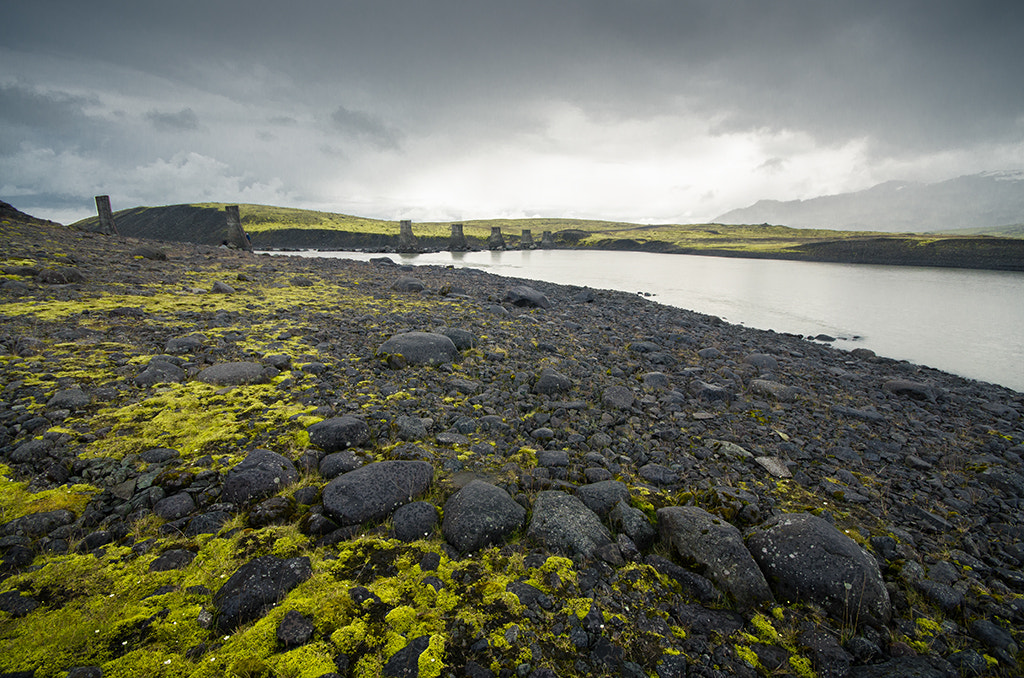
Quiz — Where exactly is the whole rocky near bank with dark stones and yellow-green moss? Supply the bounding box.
[0,214,1024,678]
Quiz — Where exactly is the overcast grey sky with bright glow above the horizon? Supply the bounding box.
[0,0,1024,222]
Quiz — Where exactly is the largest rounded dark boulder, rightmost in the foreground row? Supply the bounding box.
[746,513,891,627]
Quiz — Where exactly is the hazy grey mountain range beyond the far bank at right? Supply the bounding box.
[715,171,1024,233]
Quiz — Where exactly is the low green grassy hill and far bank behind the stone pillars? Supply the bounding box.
[73,203,1024,270]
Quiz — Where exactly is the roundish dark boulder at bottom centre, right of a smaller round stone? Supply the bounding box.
[441,480,526,553]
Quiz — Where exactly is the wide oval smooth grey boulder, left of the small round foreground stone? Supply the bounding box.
[323,461,434,526]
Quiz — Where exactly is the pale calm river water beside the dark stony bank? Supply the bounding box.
[270,250,1024,391]
